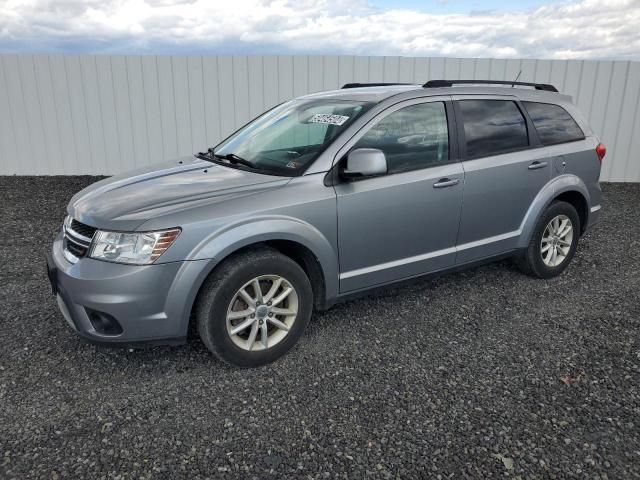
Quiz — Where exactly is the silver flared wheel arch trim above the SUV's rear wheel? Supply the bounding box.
[518,174,591,248]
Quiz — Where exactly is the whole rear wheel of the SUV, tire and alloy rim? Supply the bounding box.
[518,201,580,278]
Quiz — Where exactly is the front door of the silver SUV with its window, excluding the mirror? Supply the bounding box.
[334,97,464,293]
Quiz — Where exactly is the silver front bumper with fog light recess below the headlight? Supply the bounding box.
[47,235,212,344]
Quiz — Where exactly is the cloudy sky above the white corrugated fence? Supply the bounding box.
[0,0,640,60]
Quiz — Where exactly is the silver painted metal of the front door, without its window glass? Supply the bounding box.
[335,95,464,293]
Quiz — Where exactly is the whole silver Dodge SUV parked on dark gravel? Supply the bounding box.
[47,80,605,366]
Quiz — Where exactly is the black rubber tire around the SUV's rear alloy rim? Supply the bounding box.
[516,201,580,278]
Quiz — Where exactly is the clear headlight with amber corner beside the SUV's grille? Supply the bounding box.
[89,228,180,265]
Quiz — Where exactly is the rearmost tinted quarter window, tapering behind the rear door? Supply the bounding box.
[523,102,584,145]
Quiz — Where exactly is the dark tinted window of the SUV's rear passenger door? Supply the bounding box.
[459,100,529,158]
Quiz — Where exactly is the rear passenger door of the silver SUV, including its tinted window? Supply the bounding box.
[454,95,552,263]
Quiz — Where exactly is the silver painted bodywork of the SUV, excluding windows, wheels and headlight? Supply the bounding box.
[48,86,600,342]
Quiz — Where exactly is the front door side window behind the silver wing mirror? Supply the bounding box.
[354,102,449,173]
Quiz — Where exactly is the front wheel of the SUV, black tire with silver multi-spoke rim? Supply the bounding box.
[195,247,313,367]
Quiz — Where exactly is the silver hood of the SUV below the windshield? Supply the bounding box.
[67,157,291,231]
